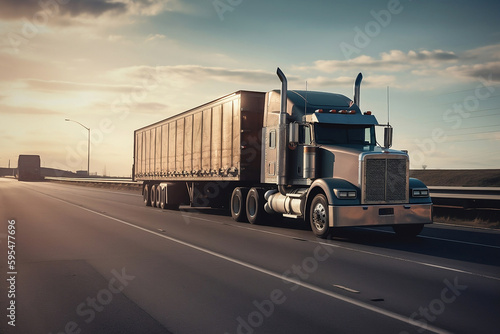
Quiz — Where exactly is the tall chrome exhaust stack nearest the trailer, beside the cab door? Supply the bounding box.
[276,67,288,195]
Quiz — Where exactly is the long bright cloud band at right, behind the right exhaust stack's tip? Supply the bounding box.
[293,44,500,89]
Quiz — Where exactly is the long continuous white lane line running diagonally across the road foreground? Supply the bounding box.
[37,194,450,334]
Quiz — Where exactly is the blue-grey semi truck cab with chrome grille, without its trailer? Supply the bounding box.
[261,70,432,237]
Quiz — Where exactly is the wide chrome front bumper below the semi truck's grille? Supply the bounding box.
[328,204,432,227]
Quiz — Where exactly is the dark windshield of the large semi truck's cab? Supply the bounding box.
[314,123,376,145]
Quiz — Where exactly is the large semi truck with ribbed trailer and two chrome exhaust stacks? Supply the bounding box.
[133,68,432,238]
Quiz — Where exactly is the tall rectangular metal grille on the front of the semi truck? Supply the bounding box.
[363,157,408,204]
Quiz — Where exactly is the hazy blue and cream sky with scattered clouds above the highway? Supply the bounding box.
[0,0,500,176]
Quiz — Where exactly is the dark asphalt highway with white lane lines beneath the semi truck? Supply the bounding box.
[0,179,500,334]
